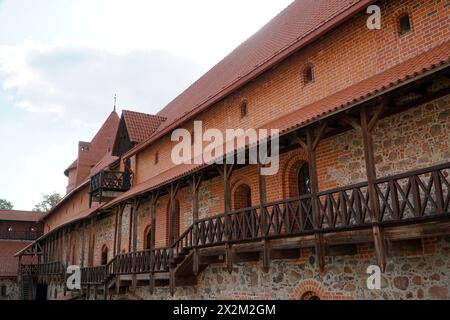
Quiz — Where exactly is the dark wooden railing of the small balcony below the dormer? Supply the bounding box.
[91,170,131,194]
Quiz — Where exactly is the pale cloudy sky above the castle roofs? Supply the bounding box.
[0,0,293,210]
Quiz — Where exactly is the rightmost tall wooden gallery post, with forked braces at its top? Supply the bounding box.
[360,103,386,272]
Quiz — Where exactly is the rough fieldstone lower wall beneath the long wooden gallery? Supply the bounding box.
[118,237,450,300]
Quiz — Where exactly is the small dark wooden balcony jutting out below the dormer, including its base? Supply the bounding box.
[90,170,131,204]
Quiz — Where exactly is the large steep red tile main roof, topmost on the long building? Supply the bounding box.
[125,0,375,157]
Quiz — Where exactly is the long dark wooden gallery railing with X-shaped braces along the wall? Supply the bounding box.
[75,163,450,286]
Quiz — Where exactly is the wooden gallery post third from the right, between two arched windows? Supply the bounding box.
[258,159,270,273]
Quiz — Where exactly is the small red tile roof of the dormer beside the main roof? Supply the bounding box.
[122,110,166,143]
